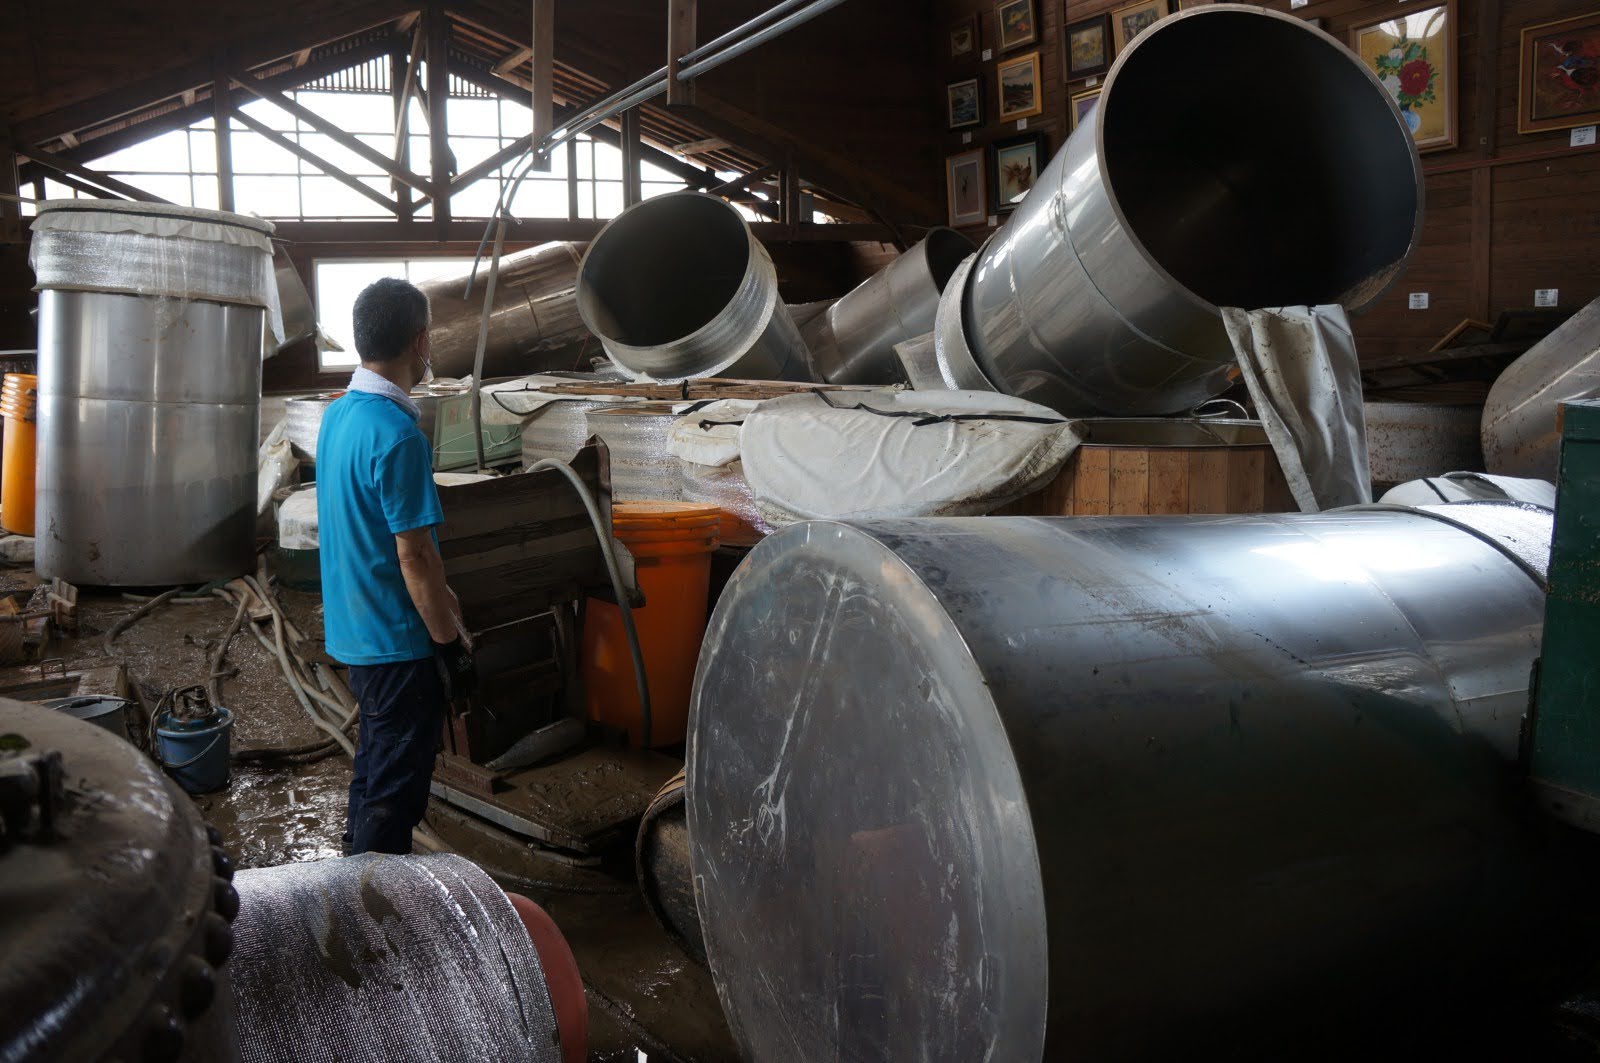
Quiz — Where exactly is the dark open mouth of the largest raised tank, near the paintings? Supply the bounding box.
[1099,11,1419,309]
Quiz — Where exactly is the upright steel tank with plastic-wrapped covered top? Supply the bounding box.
[29,200,274,586]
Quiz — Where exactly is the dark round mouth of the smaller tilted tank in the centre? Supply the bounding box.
[578,192,750,347]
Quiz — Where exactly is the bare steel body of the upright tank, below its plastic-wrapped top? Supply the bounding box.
[35,288,266,586]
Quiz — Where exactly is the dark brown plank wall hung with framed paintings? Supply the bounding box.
[934,0,1600,359]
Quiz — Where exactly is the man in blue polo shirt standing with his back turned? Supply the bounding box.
[317,277,474,853]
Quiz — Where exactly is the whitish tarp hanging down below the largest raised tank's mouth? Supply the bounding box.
[1222,306,1373,512]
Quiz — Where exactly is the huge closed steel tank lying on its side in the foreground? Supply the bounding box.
[688,503,1592,1061]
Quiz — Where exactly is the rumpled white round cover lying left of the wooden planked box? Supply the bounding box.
[732,391,1080,527]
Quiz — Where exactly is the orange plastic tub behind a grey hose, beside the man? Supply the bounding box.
[582,501,722,746]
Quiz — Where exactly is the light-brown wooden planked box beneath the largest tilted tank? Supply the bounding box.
[997,418,1299,517]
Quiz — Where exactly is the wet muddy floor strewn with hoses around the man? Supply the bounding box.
[15,568,738,1063]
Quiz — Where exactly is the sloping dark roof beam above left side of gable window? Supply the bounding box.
[13,0,410,144]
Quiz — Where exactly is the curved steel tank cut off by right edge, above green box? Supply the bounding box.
[1480,299,1600,483]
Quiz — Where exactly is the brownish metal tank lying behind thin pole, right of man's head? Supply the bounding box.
[418,243,598,378]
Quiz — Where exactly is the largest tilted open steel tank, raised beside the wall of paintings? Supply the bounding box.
[938,3,1422,416]
